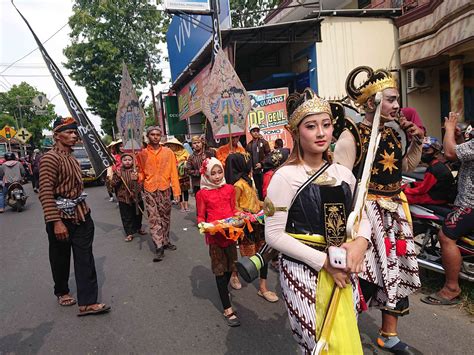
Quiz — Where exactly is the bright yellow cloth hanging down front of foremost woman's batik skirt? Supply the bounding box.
[316,269,363,354]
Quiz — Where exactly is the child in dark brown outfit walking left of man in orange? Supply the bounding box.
[111,153,146,242]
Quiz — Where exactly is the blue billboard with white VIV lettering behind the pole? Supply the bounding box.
[166,0,231,82]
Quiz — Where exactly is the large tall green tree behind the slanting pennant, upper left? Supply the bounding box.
[64,0,169,134]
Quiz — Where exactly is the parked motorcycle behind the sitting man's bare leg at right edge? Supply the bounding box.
[403,172,474,281]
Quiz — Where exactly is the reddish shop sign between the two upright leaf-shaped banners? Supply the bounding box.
[178,64,211,120]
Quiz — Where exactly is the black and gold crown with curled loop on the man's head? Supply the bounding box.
[346,66,398,106]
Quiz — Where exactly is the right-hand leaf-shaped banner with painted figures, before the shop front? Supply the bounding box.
[202,49,250,139]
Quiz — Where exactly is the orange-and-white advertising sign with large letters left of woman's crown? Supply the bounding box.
[246,88,293,149]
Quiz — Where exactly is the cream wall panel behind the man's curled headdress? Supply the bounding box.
[316,17,400,98]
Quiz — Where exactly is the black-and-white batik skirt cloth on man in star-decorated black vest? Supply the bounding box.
[359,200,421,309]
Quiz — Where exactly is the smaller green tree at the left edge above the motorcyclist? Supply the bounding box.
[0,82,56,147]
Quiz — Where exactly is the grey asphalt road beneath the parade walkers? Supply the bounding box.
[0,186,474,354]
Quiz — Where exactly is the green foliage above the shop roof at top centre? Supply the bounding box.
[230,0,282,27]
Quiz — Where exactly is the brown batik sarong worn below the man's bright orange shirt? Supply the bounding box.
[143,189,171,248]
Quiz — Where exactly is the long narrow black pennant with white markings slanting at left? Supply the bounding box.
[12,0,114,176]
